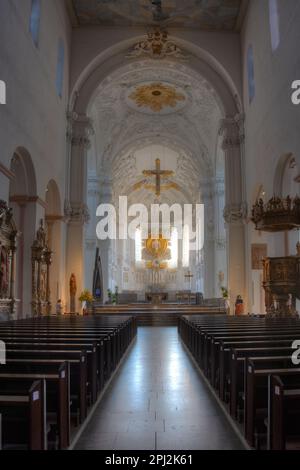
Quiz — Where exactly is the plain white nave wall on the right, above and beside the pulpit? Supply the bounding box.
[241,0,300,313]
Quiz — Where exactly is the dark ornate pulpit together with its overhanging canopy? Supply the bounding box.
[252,196,300,316]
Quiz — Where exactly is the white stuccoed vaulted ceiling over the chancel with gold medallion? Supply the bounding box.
[89,60,222,203]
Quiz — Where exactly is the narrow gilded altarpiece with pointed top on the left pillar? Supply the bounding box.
[31,220,52,316]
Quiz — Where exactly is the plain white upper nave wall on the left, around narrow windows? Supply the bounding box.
[0,0,71,204]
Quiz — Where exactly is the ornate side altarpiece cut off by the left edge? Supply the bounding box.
[0,201,18,320]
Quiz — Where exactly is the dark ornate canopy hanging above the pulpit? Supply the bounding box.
[251,196,300,232]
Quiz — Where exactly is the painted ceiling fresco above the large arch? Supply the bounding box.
[71,0,243,31]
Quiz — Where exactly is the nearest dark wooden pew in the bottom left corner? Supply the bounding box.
[0,378,46,450]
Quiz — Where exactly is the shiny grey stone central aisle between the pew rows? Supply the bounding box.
[76,327,243,450]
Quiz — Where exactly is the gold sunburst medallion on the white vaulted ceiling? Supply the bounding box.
[129,83,185,113]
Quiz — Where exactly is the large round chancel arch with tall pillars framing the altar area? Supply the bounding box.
[67,36,247,314]
